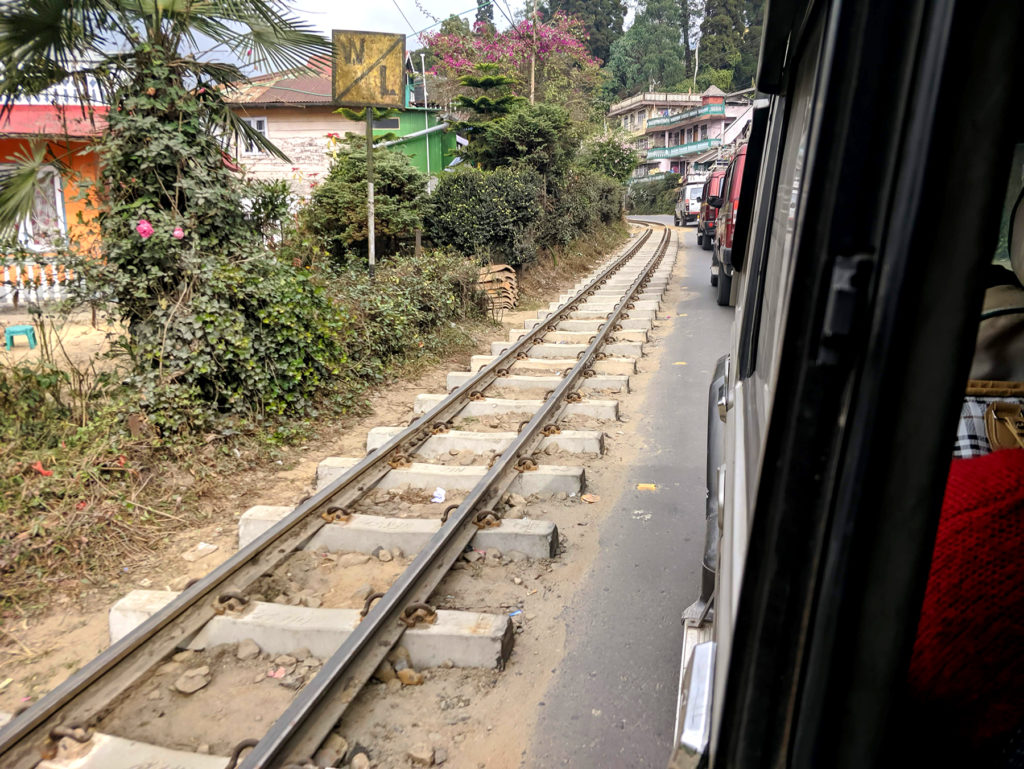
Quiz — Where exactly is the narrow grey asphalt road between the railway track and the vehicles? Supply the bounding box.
[522,216,733,769]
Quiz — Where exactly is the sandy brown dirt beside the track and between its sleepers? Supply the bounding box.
[0,222,680,769]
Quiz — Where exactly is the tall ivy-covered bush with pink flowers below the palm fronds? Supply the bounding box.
[62,46,343,431]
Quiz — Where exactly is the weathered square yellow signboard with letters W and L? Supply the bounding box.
[332,30,406,108]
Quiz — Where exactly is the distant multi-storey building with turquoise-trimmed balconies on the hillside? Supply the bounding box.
[608,86,751,179]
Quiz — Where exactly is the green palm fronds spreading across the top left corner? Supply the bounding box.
[0,0,331,232]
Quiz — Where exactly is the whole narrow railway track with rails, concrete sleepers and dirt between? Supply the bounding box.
[0,219,675,769]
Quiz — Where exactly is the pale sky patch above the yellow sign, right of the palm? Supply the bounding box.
[290,0,522,48]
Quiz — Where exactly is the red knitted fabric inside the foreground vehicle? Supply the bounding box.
[909,450,1024,744]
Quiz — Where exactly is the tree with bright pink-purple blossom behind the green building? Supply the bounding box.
[423,13,603,120]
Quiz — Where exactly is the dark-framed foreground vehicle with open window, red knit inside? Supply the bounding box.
[670,0,1024,769]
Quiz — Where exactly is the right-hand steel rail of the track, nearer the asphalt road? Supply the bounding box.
[241,227,672,769]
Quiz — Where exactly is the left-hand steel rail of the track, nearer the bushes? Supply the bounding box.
[0,224,652,769]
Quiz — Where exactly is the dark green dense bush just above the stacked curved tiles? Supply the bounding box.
[425,166,544,265]
